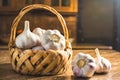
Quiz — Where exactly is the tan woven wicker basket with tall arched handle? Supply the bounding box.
[9,4,72,75]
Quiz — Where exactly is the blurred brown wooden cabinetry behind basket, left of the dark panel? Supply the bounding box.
[0,0,78,44]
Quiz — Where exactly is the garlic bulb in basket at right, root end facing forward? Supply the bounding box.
[41,30,65,50]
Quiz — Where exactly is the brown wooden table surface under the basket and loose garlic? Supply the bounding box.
[0,50,120,80]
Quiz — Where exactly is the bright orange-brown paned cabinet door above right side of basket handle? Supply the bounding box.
[44,0,78,12]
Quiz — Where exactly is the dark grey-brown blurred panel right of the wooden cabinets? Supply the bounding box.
[77,0,115,45]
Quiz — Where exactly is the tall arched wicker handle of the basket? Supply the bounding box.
[8,4,70,48]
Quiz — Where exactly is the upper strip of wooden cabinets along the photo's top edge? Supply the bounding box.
[0,0,78,12]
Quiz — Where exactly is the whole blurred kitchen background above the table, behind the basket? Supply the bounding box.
[0,0,120,50]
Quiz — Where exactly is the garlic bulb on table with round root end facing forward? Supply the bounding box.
[72,53,96,77]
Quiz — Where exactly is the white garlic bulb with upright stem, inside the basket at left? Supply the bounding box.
[15,21,40,49]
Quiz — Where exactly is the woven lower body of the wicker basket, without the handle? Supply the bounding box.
[10,48,72,75]
